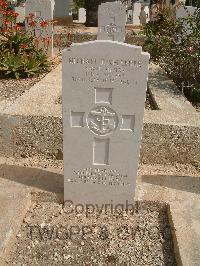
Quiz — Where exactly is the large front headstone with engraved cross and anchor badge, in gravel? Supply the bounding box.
[62,41,149,204]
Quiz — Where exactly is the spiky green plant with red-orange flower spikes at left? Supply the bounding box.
[0,0,56,78]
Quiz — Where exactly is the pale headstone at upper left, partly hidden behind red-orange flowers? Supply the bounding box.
[25,0,54,56]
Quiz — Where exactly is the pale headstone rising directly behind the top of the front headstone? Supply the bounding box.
[97,2,126,42]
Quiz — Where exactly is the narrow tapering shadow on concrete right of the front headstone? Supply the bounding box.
[141,175,200,194]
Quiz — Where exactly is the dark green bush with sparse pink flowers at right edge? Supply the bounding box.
[144,6,200,102]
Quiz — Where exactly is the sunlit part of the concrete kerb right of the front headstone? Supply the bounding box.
[138,176,200,266]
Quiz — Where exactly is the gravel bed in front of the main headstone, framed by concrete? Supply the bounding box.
[6,202,176,266]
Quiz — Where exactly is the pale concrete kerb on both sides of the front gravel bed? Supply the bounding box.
[0,160,200,266]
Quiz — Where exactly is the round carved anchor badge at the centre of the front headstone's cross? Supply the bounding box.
[87,106,119,136]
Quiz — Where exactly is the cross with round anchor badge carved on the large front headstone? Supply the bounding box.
[70,88,135,165]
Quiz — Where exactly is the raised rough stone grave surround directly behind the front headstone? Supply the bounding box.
[0,65,200,164]
